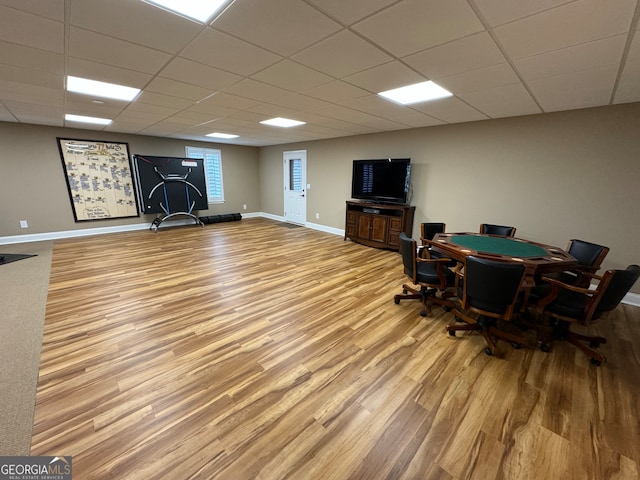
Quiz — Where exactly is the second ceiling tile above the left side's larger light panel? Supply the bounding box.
[69,27,171,73]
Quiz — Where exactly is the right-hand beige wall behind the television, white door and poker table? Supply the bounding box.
[260,103,640,293]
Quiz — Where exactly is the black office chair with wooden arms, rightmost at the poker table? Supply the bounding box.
[532,265,640,365]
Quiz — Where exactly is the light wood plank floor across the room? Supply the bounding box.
[32,219,640,480]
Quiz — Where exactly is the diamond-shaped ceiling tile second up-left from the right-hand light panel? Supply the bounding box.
[291,30,393,78]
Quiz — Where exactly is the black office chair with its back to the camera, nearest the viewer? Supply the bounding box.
[447,256,528,355]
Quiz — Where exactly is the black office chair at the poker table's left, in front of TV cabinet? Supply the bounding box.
[393,232,455,317]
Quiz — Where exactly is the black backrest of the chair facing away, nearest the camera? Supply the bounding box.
[463,256,525,319]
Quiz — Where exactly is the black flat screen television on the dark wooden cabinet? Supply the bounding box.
[351,158,411,204]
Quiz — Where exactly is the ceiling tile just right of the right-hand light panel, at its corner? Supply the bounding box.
[460,84,542,118]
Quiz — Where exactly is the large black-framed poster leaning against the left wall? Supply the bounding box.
[58,137,140,222]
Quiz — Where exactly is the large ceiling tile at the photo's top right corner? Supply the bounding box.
[495,0,637,60]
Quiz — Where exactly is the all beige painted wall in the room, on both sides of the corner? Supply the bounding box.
[0,103,640,293]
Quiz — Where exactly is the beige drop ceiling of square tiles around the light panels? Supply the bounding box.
[0,0,640,146]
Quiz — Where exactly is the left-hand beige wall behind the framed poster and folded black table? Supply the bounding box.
[0,122,260,237]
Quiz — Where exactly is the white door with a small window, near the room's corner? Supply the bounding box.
[284,150,307,225]
